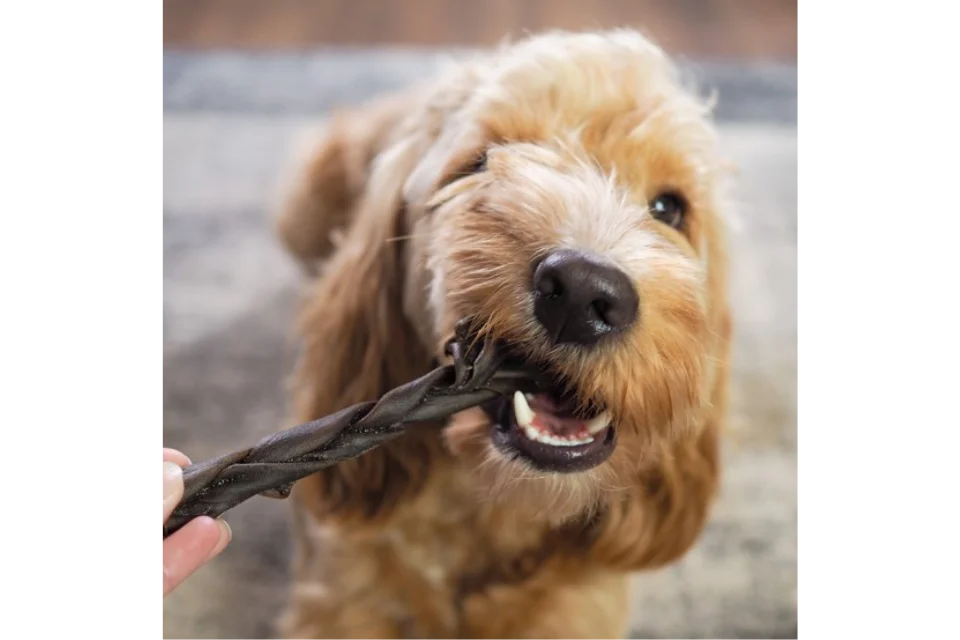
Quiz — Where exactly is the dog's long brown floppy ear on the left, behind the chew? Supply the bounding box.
[280,105,437,518]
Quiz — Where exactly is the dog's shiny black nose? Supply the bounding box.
[533,250,640,346]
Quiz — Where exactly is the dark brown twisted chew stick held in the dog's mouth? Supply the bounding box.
[160,321,536,542]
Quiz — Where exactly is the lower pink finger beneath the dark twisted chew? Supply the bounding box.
[160,516,232,598]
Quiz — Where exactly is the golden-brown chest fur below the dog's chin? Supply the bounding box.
[295,462,608,640]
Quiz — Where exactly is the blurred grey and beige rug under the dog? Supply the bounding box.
[160,51,800,640]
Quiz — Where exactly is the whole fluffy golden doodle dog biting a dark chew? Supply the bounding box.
[278,30,731,640]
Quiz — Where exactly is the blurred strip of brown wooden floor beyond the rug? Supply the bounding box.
[161,0,800,60]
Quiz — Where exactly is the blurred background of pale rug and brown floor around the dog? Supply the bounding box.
[160,0,800,640]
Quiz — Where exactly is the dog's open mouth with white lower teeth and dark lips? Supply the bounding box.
[483,350,616,473]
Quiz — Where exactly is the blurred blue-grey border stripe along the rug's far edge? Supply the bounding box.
[160,49,800,125]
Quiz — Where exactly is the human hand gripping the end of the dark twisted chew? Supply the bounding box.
[160,449,231,599]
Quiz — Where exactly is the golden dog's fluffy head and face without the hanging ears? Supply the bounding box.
[284,31,726,536]
